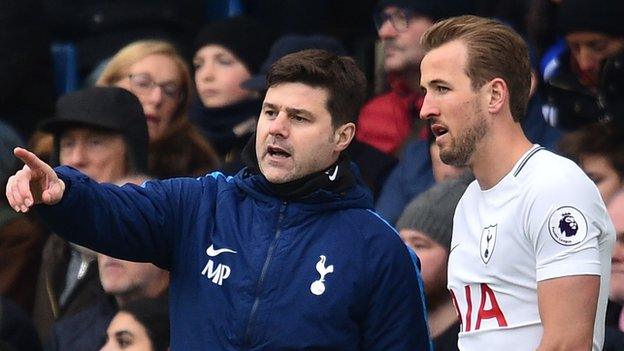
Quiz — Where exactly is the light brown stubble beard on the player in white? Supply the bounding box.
[440,100,488,167]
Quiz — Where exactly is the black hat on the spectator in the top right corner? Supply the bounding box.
[557,0,624,37]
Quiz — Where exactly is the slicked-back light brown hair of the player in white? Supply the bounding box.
[421,16,531,122]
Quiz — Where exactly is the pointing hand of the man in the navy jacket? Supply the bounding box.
[6,147,65,212]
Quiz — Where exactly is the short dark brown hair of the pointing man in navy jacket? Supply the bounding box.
[267,49,366,128]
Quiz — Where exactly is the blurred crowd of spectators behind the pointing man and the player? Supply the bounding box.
[0,0,624,350]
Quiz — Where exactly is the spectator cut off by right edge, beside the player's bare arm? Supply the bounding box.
[604,188,624,351]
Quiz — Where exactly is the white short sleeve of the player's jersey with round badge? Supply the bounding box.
[525,174,606,281]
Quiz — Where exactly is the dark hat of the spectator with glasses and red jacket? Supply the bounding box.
[377,0,474,22]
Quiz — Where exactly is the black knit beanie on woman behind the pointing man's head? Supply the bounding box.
[194,17,271,74]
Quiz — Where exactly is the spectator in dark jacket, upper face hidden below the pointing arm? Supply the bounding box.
[46,248,169,351]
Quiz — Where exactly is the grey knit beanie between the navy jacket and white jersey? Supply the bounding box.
[397,172,474,250]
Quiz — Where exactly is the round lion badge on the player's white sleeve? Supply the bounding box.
[548,206,587,246]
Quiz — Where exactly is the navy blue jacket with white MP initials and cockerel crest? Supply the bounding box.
[38,167,431,350]
